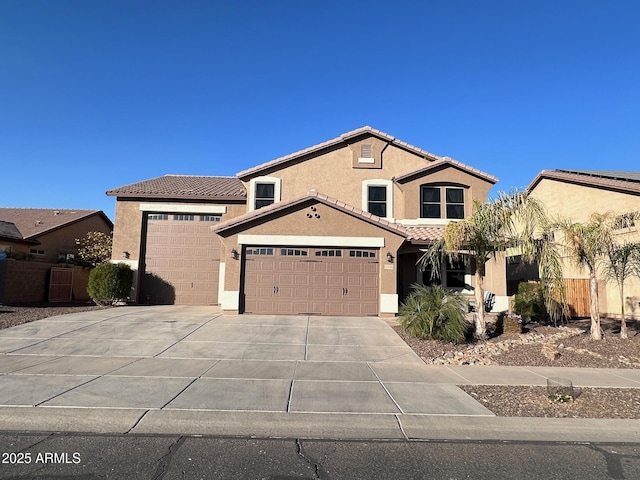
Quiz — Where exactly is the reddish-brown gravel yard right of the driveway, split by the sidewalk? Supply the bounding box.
[394,319,640,419]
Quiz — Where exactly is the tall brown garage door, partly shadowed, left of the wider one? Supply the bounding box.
[139,213,220,305]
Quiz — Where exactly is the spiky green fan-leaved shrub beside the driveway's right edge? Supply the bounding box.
[400,285,470,343]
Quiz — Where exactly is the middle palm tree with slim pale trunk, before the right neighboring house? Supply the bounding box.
[554,212,640,340]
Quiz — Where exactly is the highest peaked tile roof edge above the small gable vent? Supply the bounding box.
[237,125,443,178]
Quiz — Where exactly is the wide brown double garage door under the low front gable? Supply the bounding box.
[244,247,379,316]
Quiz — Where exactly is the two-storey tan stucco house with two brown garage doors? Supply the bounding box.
[107,127,506,316]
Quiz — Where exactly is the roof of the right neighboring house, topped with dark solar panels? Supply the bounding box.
[527,170,640,195]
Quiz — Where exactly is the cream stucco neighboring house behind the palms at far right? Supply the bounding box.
[524,170,640,318]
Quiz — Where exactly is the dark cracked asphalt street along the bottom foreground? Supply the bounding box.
[0,433,640,480]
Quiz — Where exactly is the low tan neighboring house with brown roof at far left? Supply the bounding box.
[0,208,113,263]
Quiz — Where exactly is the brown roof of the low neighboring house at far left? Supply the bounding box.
[0,208,113,239]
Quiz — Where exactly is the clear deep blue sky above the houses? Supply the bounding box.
[0,0,640,219]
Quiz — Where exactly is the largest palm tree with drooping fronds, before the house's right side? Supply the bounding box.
[418,191,562,338]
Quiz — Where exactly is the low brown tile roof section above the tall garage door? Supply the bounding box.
[107,175,247,200]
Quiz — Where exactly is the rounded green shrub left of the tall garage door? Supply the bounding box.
[87,263,133,305]
